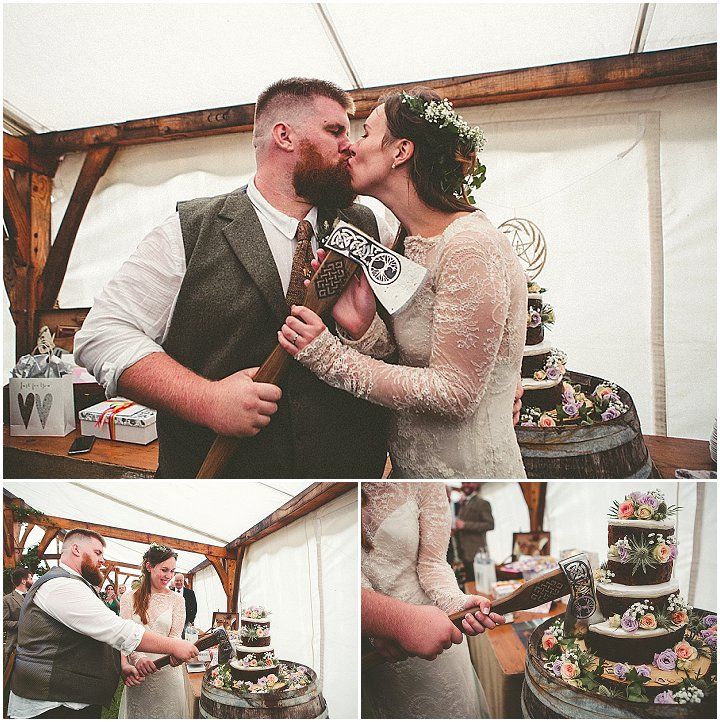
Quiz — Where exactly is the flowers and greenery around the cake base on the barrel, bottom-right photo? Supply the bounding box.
[541,612,717,704]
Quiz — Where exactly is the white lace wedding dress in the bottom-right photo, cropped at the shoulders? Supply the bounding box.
[362,481,489,719]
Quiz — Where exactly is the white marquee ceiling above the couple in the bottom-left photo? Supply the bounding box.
[3,480,310,571]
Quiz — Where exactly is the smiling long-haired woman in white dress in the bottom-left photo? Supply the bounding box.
[118,544,194,719]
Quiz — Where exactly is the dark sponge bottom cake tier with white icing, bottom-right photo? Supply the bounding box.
[585,622,686,664]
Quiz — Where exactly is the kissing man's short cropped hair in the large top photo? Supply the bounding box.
[253,78,355,146]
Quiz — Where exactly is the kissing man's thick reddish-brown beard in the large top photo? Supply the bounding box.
[292,140,355,208]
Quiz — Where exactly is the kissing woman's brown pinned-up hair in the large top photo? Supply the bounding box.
[378,87,484,211]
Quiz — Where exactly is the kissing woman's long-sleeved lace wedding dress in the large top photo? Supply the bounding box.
[296,211,527,479]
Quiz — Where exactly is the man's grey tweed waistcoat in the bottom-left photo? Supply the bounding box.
[10,567,120,707]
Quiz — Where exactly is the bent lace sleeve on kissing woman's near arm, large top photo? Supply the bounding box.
[296,225,510,419]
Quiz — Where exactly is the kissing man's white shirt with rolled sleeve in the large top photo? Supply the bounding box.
[74,177,393,398]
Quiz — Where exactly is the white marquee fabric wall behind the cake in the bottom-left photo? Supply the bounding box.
[194,493,360,718]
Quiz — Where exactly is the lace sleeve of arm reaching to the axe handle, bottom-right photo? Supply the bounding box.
[417,482,468,614]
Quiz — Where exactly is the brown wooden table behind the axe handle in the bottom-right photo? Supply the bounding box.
[465,582,566,719]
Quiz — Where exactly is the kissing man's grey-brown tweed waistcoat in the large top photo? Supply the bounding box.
[158,188,388,478]
